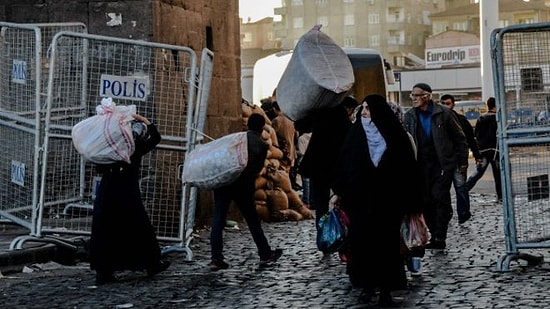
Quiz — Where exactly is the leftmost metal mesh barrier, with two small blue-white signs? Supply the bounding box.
[0,22,87,235]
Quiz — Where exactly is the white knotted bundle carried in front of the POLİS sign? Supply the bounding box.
[71,98,136,164]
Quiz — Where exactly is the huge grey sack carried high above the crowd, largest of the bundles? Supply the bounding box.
[277,26,355,120]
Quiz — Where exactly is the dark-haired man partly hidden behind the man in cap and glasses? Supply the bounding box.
[440,94,481,224]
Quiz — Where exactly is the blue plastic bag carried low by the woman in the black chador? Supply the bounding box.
[317,208,346,253]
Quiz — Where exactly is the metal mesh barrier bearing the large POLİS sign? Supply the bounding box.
[29,31,213,259]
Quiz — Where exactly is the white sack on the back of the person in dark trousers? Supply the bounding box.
[182,132,248,190]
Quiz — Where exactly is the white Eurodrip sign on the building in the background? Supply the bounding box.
[424,45,481,69]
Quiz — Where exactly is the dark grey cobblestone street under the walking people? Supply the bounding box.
[0,194,550,308]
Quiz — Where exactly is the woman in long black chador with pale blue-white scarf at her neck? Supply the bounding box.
[333,95,422,305]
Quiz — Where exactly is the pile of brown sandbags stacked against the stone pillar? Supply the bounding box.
[241,102,313,222]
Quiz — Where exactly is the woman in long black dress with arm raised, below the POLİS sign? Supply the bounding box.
[90,115,169,284]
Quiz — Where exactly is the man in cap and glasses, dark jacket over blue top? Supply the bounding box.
[405,83,468,249]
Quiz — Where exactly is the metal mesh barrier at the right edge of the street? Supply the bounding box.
[491,23,550,271]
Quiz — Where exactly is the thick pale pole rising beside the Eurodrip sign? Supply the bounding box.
[479,0,499,101]
